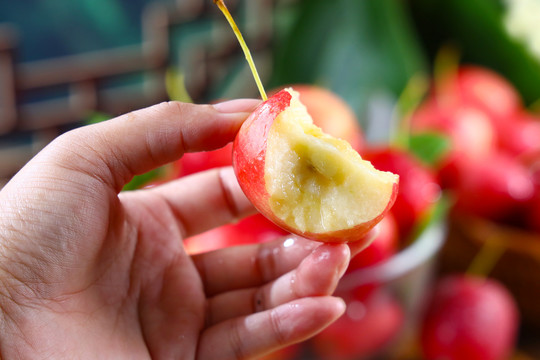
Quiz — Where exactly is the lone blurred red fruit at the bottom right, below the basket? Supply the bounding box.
[421,275,519,360]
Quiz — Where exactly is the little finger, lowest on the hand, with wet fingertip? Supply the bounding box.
[198,296,345,360]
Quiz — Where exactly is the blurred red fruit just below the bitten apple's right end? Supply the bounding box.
[347,212,399,272]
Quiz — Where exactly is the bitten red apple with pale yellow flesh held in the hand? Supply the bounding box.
[233,89,399,242]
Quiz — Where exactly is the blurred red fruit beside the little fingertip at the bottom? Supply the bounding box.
[311,289,405,360]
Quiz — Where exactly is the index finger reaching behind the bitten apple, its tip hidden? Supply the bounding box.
[133,167,255,238]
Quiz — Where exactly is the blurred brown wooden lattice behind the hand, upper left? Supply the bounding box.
[0,0,275,179]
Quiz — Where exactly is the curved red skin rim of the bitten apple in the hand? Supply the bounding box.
[233,90,399,243]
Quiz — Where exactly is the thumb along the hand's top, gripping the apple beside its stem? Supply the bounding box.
[45,99,259,191]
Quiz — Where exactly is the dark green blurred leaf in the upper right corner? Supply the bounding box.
[410,0,540,104]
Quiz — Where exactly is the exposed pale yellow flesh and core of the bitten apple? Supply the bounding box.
[264,89,398,233]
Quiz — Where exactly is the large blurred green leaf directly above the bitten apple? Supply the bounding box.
[273,0,426,119]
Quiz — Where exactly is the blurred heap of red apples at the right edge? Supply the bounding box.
[411,66,540,231]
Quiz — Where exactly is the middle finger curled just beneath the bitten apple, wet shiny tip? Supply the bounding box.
[192,235,321,296]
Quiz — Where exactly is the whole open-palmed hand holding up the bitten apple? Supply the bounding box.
[0,100,362,360]
